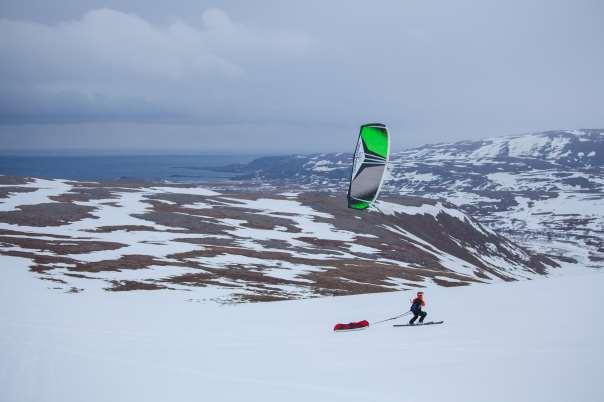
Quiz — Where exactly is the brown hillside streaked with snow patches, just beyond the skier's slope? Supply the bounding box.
[0,177,559,302]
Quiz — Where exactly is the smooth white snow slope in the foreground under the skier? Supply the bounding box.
[0,257,604,402]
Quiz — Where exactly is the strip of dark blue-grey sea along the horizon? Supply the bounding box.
[0,154,260,182]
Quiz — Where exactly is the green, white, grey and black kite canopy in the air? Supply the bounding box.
[348,123,390,209]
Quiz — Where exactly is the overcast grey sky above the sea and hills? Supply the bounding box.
[0,0,604,153]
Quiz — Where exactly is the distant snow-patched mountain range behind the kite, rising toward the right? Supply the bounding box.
[214,129,604,267]
